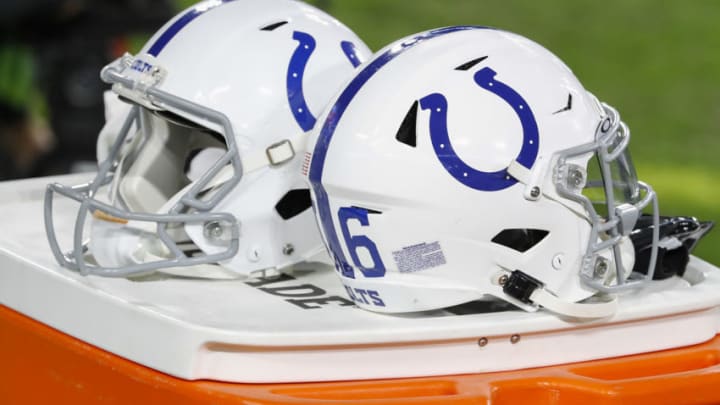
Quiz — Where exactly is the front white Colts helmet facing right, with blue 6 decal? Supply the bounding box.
[307,27,658,318]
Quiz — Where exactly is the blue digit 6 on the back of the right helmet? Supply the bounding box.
[338,207,385,277]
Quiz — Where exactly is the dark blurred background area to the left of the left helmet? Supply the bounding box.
[0,0,177,179]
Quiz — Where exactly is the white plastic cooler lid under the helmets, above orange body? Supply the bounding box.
[0,176,720,382]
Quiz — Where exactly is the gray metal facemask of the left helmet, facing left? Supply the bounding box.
[44,55,248,277]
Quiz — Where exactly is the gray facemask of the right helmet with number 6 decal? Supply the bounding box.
[555,103,660,293]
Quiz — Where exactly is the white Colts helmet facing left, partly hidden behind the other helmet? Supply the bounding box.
[45,0,370,277]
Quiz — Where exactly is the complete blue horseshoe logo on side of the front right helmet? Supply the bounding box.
[420,67,539,191]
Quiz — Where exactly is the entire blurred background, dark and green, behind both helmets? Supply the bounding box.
[0,0,720,264]
